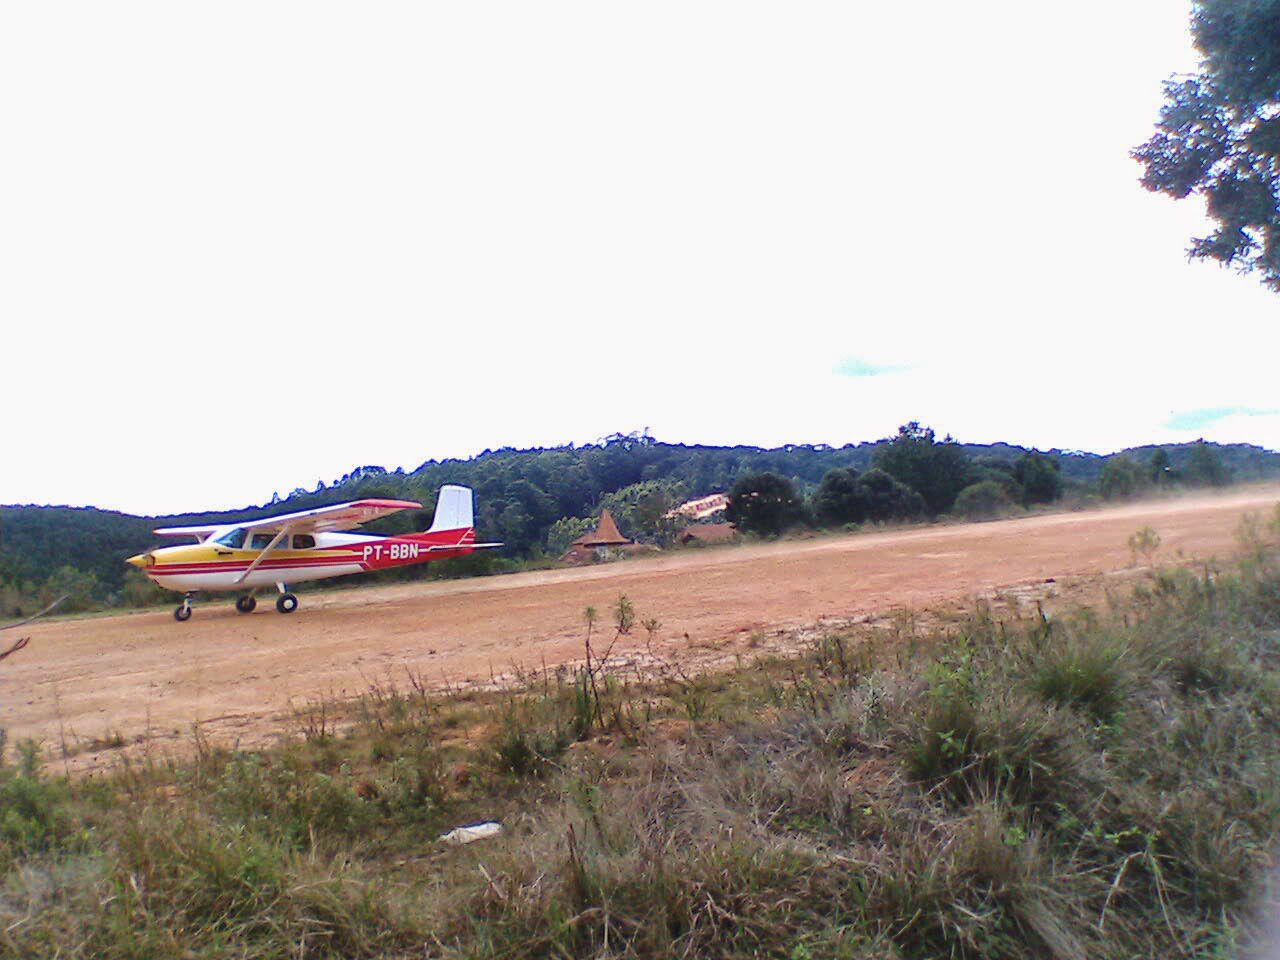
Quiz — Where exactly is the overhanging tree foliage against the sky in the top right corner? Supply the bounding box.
[1133,0,1280,292]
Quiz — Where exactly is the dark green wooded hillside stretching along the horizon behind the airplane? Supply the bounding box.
[0,435,1280,616]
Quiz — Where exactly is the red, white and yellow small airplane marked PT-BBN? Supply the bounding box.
[125,484,502,623]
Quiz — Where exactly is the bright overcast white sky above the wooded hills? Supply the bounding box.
[0,0,1280,513]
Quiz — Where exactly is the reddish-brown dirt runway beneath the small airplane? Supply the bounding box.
[0,485,1280,768]
